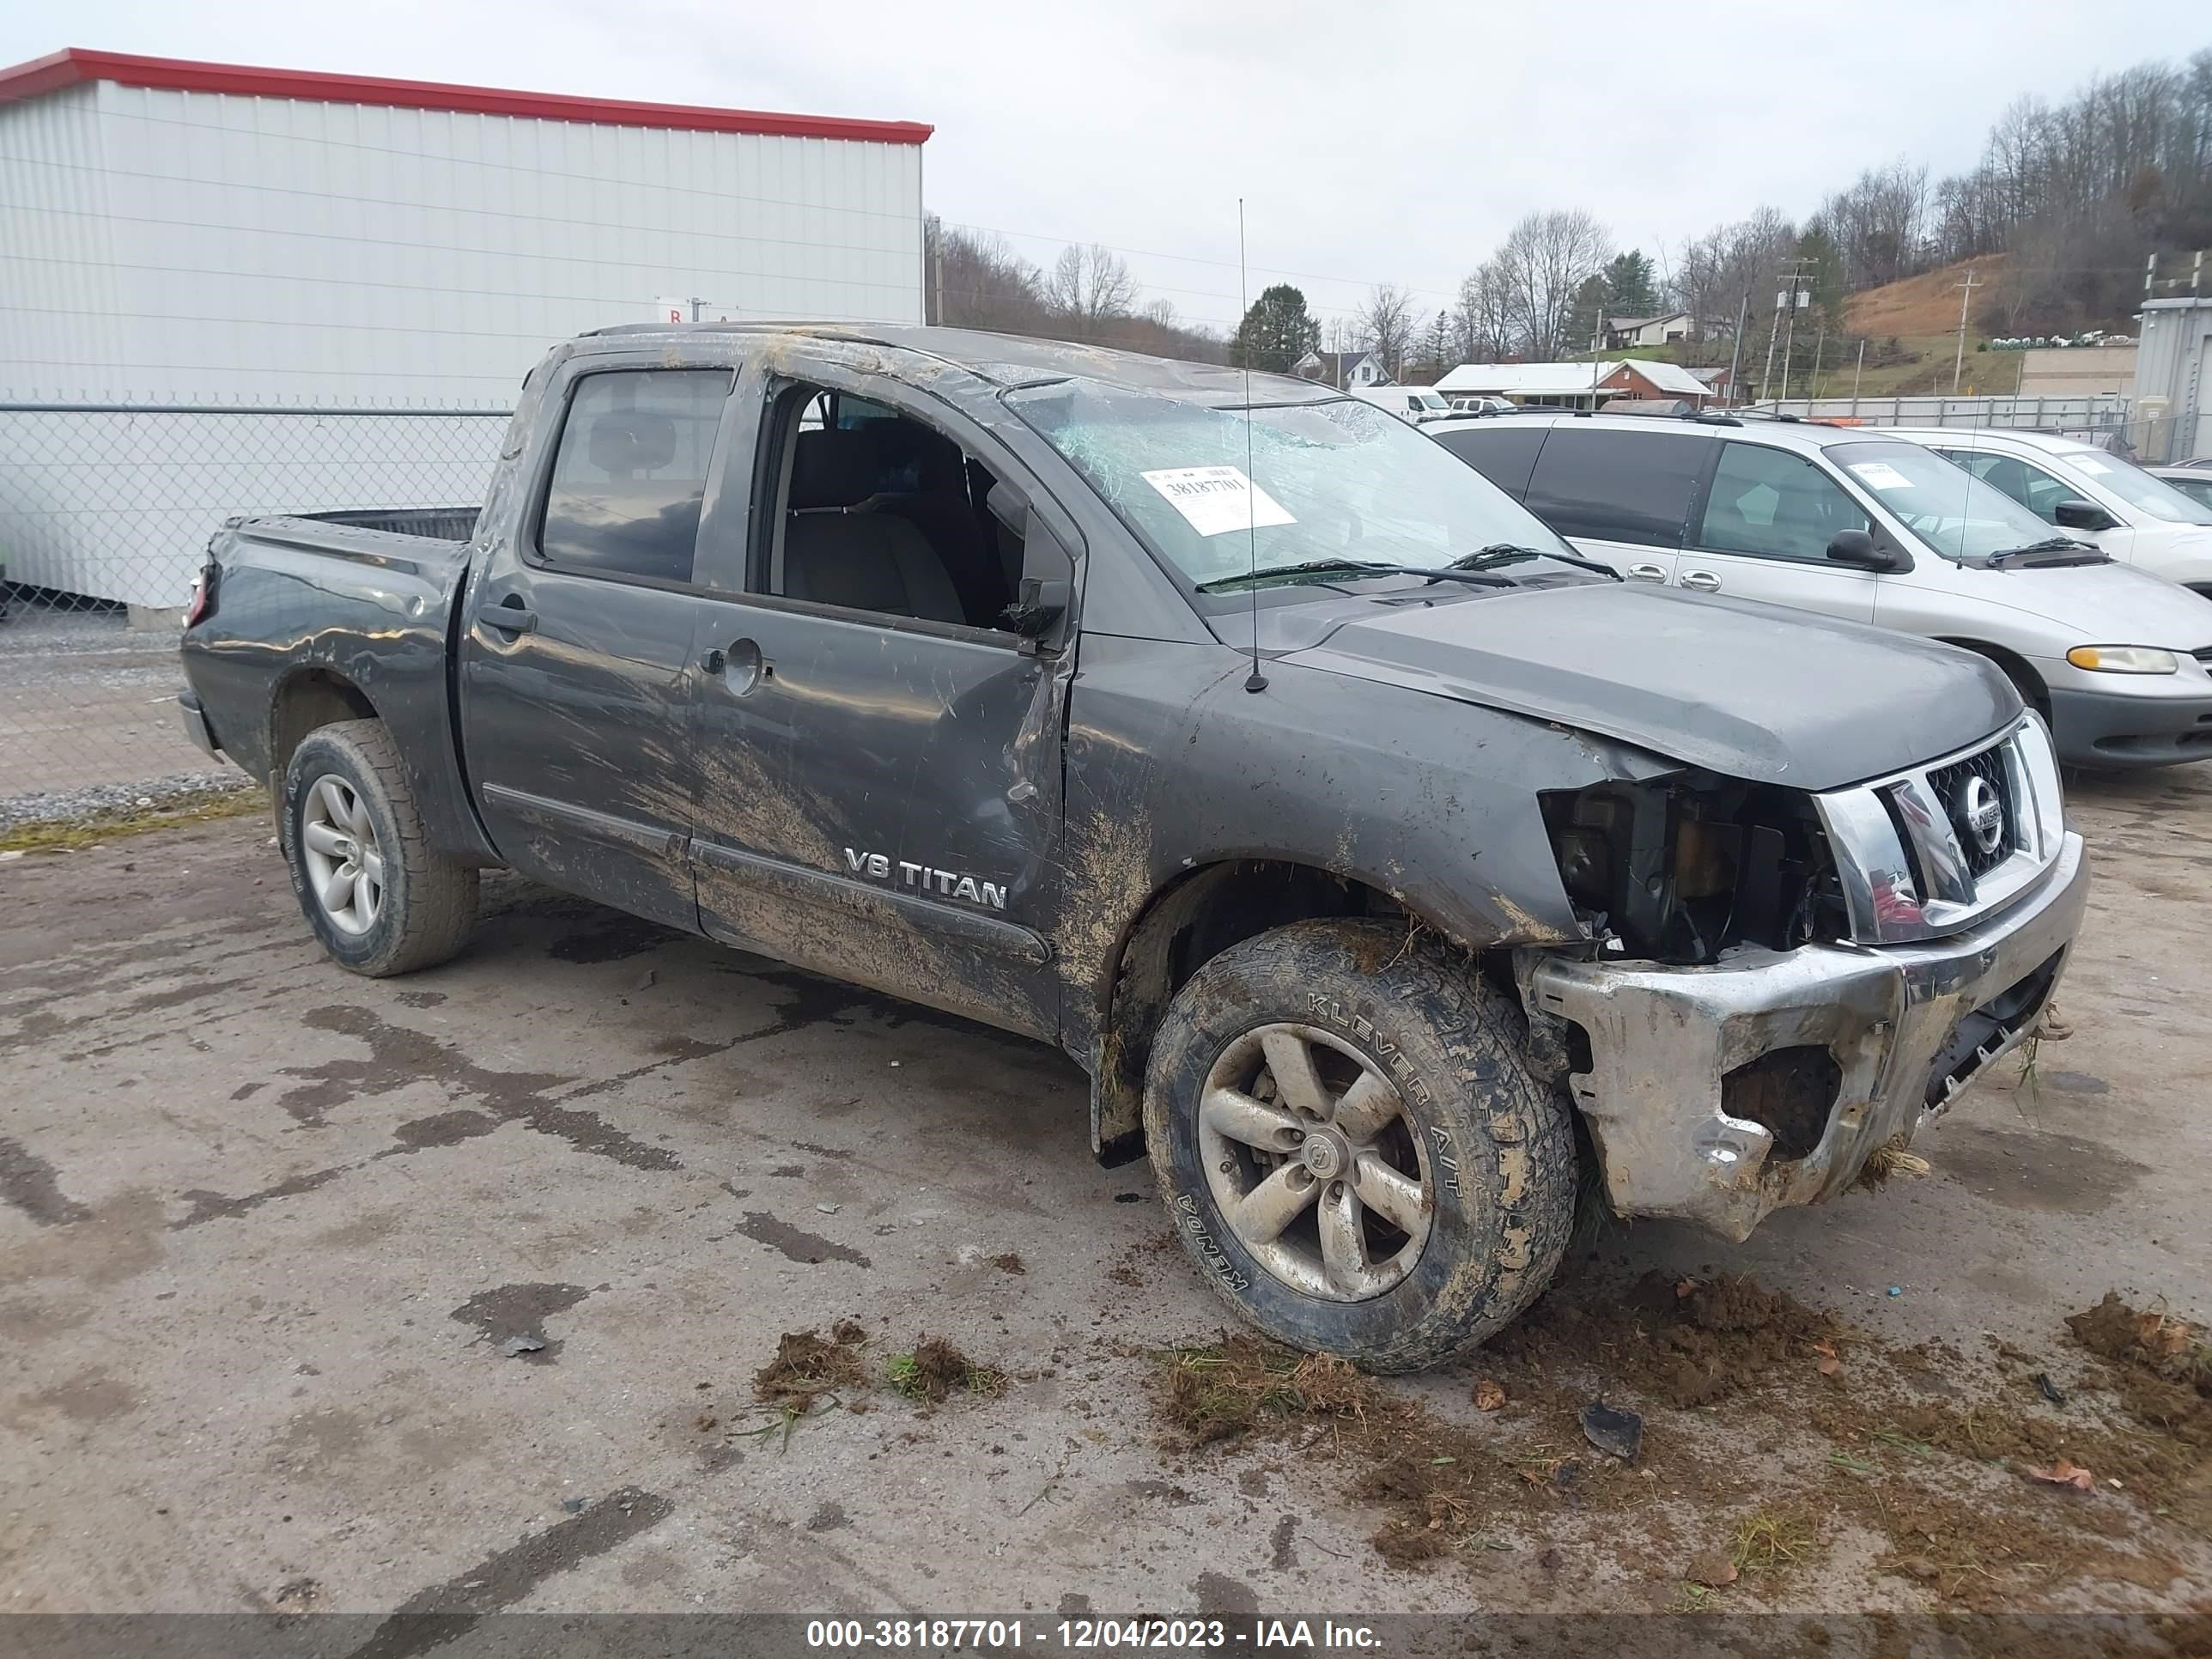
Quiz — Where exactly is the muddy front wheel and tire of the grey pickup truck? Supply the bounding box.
[1144,921,1575,1371]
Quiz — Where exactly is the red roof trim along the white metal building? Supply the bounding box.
[0,46,936,143]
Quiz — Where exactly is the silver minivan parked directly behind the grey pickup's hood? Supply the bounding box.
[1427,416,2212,768]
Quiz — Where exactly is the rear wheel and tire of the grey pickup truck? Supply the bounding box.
[276,719,476,980]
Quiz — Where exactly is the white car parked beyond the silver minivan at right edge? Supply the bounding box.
[1885,427,2212,595]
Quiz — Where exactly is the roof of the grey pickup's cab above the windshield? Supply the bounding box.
[588,323,1347,410]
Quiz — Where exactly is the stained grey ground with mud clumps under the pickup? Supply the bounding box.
[0,769,2212,1614]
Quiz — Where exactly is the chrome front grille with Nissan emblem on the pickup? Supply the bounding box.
[1816,714,2066,945]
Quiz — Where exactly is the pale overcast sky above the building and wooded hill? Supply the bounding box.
[0,0,2212,327]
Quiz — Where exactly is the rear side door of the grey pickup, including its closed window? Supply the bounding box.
[460,358,730,929]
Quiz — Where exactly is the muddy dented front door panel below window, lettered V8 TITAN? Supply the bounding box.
[692,599,1064,1037]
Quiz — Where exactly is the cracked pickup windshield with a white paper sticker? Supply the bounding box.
[1006,380,1571,586]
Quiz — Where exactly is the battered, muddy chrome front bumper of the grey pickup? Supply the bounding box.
[1522,832,2088,1241]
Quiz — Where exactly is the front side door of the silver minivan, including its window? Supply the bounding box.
[1677,438,1881,622]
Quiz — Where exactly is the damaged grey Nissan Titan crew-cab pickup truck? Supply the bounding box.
[184,325,2086,1370]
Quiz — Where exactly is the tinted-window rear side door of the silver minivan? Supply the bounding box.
[1524,422,1714,581]
